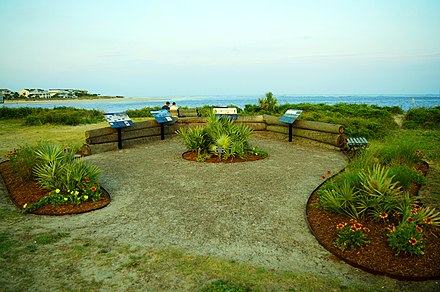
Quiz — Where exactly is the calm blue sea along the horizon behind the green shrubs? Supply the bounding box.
[3,94,440,112]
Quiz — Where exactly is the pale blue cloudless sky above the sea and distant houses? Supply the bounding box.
[0,0,440,97]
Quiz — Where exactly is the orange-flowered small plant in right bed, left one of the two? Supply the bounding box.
[333,219,370,251]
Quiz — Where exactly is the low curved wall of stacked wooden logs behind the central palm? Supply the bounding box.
[83,115,346,154]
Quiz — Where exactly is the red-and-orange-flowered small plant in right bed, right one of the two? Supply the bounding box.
[387,218,426,255]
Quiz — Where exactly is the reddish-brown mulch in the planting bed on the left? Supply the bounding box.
[0,161,110,215]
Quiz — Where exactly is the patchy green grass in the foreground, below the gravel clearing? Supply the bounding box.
[0,228,383,291]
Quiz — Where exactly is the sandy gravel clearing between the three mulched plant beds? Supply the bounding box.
[0,137,438,290]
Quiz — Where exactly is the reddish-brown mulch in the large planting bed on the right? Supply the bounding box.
[307,193,440,280]
